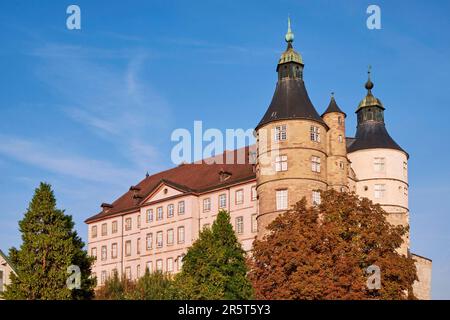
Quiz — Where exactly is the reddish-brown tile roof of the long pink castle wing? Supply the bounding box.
[85,146,256,223]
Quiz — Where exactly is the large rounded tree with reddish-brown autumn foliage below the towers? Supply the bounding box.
[250,190,417,300]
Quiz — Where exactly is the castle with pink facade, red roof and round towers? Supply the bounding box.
[86,21,431,299]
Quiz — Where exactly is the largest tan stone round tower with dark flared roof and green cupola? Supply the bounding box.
[255,20,328,238]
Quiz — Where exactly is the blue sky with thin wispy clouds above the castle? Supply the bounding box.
[0,0,450,299]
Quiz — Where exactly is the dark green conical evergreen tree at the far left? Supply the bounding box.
[4,183,95,300]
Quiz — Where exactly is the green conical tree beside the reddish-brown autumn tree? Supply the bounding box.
[175,211,253,300]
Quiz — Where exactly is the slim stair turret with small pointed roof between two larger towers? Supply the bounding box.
[322,93,349,192]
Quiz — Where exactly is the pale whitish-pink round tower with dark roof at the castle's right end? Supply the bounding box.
[347,70,409,255]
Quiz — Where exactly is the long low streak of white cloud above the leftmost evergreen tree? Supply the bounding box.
[0,135,137,185]
